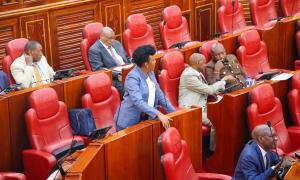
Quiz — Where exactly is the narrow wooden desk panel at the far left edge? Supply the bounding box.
[0,97,12,171]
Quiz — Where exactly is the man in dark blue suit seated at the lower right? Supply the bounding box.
[232,124,295,180]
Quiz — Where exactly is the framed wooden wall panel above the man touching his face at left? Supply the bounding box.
[20,13,53,66]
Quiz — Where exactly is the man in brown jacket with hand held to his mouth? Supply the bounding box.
[206,43,246,92]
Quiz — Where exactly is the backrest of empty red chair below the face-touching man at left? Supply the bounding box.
[25,87,83,153]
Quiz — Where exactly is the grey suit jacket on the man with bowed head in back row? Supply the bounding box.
[89,40,130,75]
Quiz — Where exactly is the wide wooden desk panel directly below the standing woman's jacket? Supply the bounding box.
[99,123,153,180]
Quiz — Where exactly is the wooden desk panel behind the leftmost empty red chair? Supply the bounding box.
[5,83,63,171]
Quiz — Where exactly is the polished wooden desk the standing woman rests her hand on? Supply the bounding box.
[66,108,202,180]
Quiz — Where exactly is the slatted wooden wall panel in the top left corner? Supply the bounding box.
[0,19,19,69]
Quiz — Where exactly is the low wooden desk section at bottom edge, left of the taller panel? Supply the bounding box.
[65,143,105,180]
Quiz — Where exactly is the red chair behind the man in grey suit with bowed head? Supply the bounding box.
[80,22,103,71]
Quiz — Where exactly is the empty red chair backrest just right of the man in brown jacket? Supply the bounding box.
[237,30,270,78]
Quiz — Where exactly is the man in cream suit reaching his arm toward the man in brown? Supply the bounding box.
[178,53,233,151]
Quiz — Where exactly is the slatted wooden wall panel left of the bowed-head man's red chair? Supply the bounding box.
[50,3,99,69]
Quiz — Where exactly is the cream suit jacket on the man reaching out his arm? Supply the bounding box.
[178,67,226,124]
